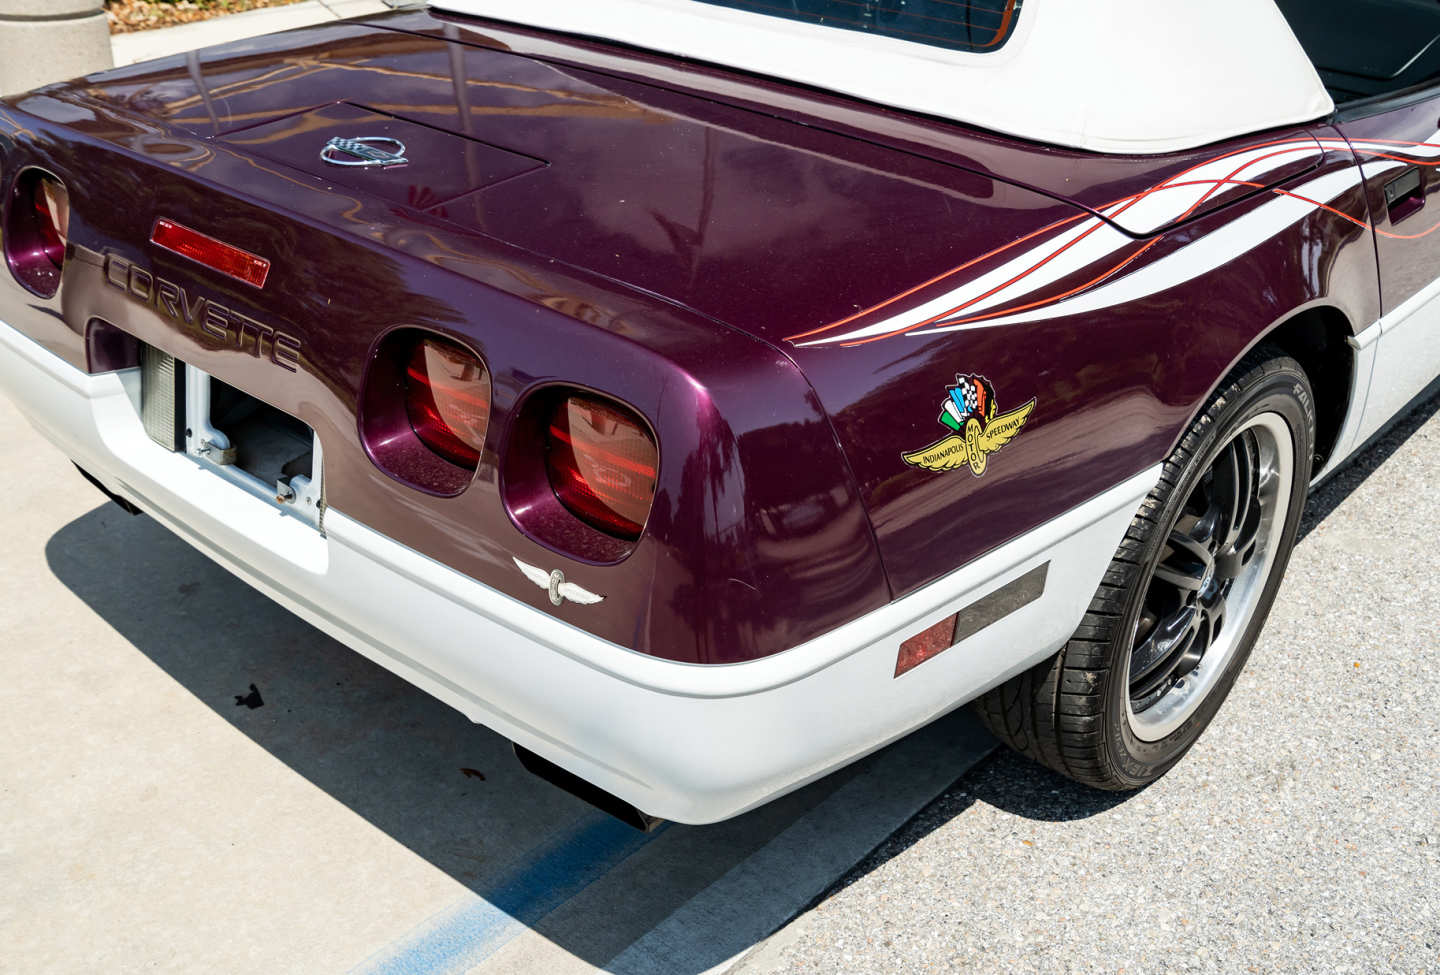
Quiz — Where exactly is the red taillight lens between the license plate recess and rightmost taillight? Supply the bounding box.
[405,338,490,469]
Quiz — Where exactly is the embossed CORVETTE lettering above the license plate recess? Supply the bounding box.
[105,253,301,372]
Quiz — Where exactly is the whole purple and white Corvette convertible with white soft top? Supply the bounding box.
[0,0,1440,825]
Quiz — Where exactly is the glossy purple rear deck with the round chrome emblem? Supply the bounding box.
[61,13,1318,347]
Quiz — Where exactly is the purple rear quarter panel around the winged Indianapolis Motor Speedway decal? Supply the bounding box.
[791,132,1380,595]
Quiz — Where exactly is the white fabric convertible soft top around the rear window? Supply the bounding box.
[432,0,1333,154]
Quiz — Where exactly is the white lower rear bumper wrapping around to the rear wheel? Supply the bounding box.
[0,323,1159,822]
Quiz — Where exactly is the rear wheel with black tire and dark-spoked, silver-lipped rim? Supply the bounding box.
[976,349,1315,789]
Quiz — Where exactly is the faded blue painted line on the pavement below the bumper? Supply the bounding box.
[353,814,665,975]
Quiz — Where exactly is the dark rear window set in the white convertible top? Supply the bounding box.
[696,0,1025,53]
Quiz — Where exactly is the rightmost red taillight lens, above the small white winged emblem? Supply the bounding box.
[546,395,658,539]
